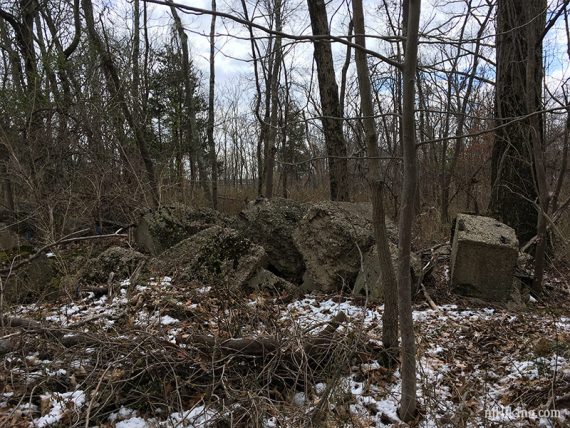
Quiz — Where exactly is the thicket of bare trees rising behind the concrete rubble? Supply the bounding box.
[0,0,570,419]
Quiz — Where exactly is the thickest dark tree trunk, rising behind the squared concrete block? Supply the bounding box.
[490,0,544,243]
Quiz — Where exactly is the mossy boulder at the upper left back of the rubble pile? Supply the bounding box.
[135,205,228,256]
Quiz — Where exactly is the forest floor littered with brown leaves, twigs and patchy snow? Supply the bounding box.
[0,256,570,428]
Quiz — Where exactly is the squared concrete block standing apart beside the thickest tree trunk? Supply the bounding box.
[451,214,519,302]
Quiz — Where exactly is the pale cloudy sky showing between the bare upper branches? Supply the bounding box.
[130,0,570,106]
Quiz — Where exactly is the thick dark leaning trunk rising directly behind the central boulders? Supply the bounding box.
[307,0,350,201]
